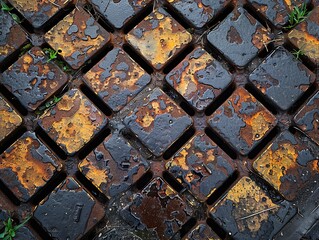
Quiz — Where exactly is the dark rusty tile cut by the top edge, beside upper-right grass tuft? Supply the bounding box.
[249,0,310,27]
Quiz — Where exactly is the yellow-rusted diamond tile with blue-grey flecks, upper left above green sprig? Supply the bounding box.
[45,8,110,69]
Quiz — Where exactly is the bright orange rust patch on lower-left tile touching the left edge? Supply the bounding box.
[0,137,56,196]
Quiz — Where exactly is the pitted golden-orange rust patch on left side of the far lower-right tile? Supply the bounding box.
[253,143,298,191]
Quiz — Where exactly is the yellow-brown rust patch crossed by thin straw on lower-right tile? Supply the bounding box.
[213,177,279,235]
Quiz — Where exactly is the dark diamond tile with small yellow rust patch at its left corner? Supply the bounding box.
[79,133,149,198]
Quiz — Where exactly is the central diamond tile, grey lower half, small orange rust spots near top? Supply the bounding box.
[124,88,193,156]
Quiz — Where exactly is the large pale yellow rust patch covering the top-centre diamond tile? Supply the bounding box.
[126,11,192,68]
